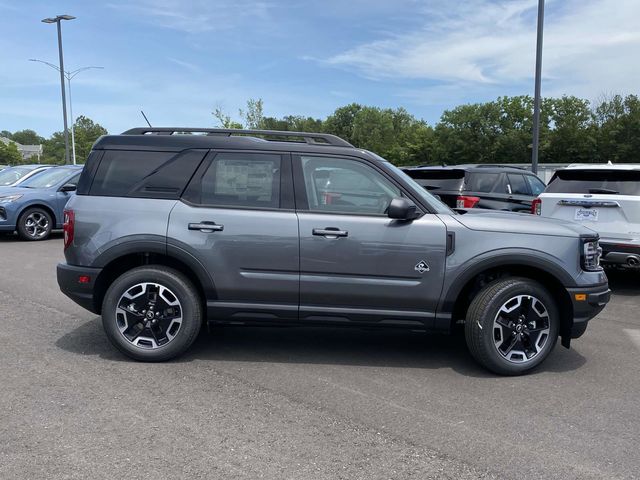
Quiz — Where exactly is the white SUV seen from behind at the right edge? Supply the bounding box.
[532,164,640,268]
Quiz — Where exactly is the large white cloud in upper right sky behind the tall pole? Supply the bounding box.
[325,0,640,98]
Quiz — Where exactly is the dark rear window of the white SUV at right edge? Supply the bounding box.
[545,170,640,195]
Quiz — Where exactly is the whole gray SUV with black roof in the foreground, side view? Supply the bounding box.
[58,128,609,375]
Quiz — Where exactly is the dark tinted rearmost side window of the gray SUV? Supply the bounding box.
[90,150,206,199]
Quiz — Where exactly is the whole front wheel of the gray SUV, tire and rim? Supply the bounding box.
[465,278,560,375]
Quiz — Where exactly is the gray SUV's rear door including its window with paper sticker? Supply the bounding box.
[167,151,299,321]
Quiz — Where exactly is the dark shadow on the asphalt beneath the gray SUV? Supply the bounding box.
[56,317,586,378]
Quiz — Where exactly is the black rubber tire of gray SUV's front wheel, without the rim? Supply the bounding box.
[474,279,560,375]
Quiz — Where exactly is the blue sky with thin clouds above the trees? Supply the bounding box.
[0,0,640,136]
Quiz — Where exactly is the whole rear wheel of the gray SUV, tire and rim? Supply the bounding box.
[102,265,203,362]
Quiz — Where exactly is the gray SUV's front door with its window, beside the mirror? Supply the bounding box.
[294,155,446,327]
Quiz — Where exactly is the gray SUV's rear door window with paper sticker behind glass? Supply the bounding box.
[201,153,281,208]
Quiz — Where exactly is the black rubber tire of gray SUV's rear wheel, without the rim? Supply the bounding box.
[102,267,202,362]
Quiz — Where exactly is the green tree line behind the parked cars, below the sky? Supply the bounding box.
[0,95,640,165]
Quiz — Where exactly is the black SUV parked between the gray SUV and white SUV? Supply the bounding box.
[403,165,545,213]
